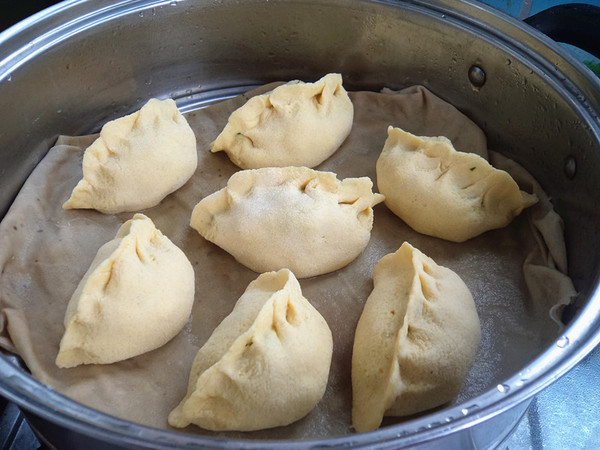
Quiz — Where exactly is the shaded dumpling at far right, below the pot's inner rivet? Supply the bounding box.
[377,127,537,242]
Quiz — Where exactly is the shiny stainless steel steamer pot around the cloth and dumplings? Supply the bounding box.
[0,0,600,448]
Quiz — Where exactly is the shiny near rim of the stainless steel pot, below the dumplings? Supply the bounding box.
[0,300,600,449]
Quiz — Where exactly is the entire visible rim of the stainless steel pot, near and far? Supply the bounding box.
[0,0,600,448]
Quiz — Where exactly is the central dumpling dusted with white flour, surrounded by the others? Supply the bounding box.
[190,167,383,278]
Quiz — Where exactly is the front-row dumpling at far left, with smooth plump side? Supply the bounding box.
[56,214,194,367]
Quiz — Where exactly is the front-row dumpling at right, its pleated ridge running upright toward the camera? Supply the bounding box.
[352,242,481,432]
